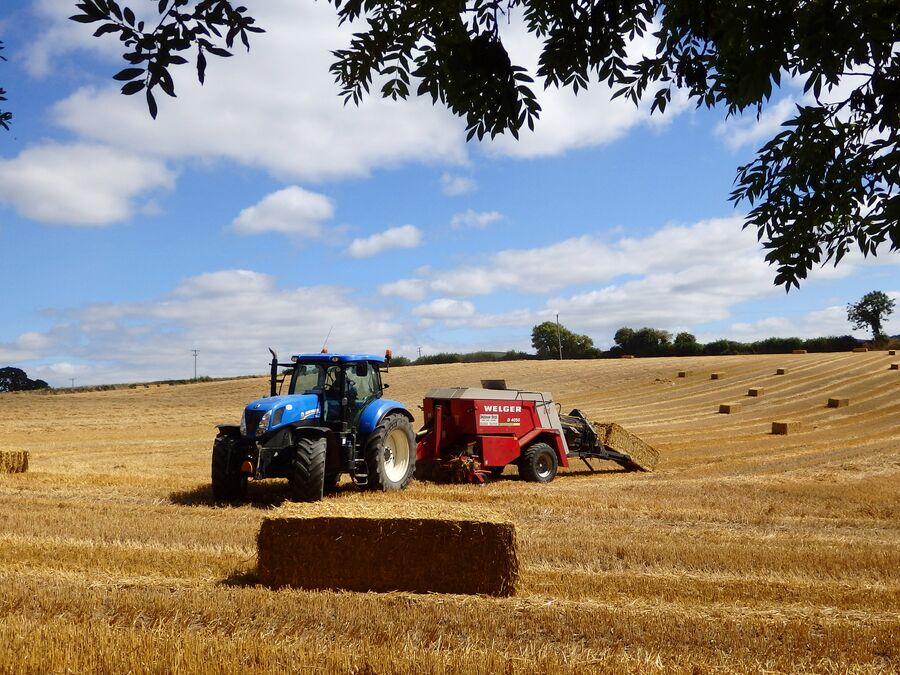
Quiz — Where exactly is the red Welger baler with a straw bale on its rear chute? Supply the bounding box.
[416,388,658,483]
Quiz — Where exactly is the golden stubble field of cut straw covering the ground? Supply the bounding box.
[0,352,900,673]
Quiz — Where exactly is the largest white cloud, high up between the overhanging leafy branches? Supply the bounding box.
[48,0,466,180]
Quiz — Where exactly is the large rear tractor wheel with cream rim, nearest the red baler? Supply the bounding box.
[366,414,416,491]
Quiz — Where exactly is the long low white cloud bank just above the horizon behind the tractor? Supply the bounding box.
[0,270,400,386]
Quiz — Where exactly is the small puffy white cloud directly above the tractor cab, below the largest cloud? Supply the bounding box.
[231,185,334,238]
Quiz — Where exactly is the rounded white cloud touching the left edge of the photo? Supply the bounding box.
[0,143,175,226]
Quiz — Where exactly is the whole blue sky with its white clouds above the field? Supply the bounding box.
[0,0,900,386]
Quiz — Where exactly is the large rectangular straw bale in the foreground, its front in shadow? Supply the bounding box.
[257,500,519,596]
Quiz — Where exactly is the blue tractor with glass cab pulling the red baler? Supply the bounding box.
[212,349,416,501]
